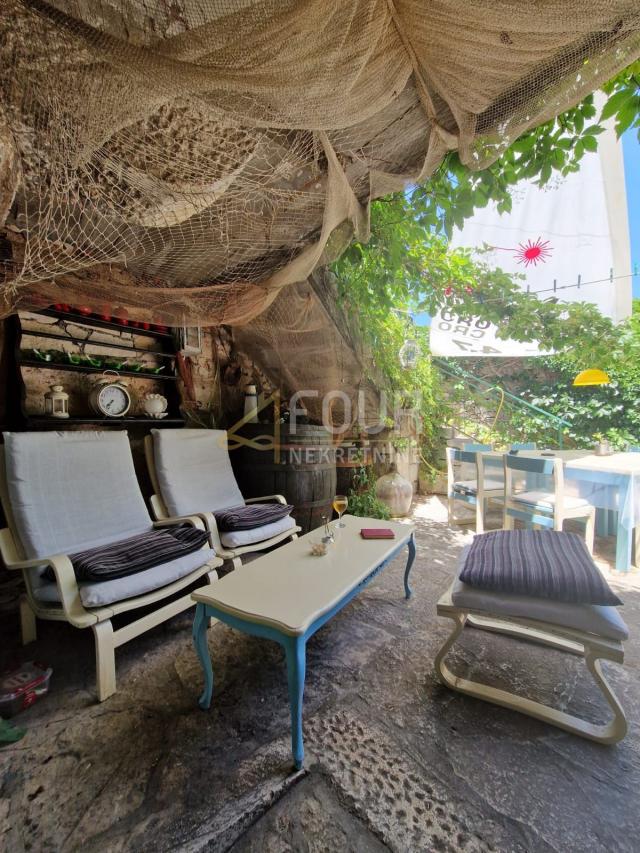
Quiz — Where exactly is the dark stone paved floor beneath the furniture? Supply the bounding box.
[0,498,640,853]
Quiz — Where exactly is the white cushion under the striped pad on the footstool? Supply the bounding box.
[451,547,629,640]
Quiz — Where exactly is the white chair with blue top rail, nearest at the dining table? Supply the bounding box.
[504,453,596,554]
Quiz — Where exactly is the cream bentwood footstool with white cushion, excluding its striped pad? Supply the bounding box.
[435,531,628,744]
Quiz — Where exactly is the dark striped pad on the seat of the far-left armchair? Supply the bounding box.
[45,524,208,582]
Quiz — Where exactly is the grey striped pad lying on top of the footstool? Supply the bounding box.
[460,530,622,606]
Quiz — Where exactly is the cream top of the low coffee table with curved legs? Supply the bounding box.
[192,515,415,635]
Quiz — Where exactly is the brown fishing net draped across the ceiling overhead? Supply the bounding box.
[0,0,640,326]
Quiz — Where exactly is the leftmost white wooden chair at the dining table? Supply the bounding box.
[446,447,504,533]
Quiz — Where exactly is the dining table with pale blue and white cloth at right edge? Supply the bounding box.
[482,449,640,572]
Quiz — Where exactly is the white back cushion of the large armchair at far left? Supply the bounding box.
[4,431,151,559]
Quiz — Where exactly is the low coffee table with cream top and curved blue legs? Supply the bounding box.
[192,515,416,769]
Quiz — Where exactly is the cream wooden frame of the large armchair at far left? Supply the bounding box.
[0,448,222,702]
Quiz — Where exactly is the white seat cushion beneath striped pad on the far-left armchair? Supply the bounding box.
[34,548,216,607]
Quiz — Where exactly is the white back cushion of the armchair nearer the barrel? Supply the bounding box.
[151,429,244,515]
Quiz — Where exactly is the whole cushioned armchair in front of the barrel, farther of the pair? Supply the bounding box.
[145,429,301,569]
